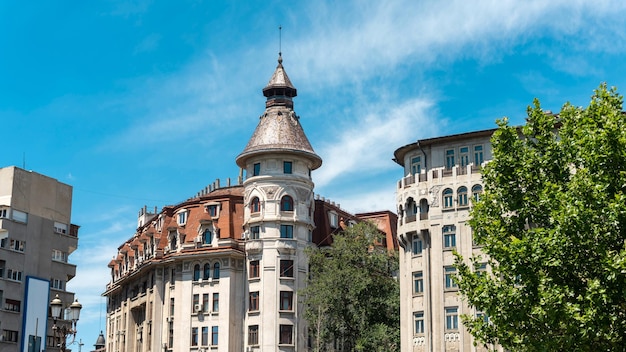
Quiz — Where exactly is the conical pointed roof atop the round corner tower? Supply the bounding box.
[236,54,322,170]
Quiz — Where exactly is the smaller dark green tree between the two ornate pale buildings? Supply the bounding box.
[302,223,400,352]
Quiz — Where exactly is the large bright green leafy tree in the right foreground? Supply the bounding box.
[456,84,626,351]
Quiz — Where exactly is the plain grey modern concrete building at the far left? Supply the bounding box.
[0,166,78,352]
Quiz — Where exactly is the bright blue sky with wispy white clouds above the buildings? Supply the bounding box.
[0,0,626,349]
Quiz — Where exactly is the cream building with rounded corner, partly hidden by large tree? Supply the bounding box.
[394,130,495,352]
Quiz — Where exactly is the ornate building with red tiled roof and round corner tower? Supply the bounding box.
[103,55,397,352]
